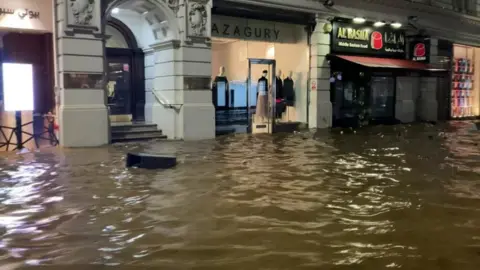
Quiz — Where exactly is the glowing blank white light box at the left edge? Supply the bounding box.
[2,63,33,112]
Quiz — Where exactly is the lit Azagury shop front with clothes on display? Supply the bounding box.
[211,15,309,134]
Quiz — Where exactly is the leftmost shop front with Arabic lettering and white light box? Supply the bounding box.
[0,0,55,150]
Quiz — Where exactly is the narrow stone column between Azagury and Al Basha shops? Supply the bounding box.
[308,15,332,128]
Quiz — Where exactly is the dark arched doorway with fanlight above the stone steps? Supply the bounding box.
[105,17,145,122]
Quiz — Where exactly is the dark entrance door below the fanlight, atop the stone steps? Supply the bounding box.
[107,56,132,118]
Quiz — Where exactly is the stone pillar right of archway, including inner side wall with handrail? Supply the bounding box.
[145,1,215,140]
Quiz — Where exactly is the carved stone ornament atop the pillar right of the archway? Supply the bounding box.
[187,1,208,37]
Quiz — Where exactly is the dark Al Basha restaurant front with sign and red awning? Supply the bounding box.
[328,19,430,127]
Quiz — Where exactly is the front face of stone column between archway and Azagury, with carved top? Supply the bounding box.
[175,0,215,140]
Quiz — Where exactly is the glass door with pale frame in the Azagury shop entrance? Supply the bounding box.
[247,58,276,133]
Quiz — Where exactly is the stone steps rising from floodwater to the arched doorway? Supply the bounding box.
[111,123,167,143]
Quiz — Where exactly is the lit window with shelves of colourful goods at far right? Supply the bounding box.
[451,45,480,118]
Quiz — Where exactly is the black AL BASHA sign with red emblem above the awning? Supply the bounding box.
[332,22,406,58]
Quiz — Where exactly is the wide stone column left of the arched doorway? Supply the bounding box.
[55,0,110,147]
